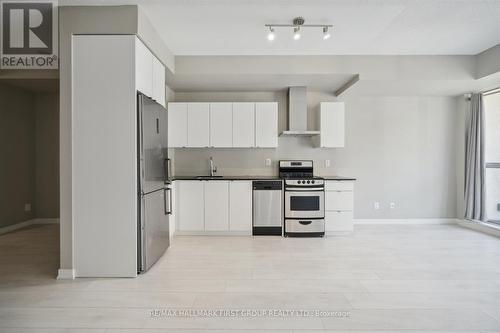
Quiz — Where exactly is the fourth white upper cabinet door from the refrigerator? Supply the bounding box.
[233,103,255,148]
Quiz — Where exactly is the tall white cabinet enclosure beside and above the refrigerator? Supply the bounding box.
[72,35,165,277]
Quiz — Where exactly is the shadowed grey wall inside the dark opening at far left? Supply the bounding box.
[0,80,59,228]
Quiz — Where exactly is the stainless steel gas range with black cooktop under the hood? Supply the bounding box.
[279,161,325,237]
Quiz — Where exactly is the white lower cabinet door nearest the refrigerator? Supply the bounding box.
[176,180,205,232]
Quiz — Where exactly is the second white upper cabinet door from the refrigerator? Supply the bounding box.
[188,103,210,147]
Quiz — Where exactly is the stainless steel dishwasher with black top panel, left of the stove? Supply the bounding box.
[252,180,283,236]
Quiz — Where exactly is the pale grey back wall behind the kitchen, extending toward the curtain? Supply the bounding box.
[175,92,460,218]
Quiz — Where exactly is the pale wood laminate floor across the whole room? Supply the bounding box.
[0,225,500,333]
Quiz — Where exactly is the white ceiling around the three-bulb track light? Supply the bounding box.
[59,0,500,55]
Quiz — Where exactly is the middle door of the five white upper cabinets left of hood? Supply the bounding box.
[210,103,233,147]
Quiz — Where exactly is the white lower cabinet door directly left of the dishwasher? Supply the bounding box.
[229,180,252,231]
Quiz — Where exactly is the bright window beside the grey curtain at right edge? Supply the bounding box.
[483,90,500,223]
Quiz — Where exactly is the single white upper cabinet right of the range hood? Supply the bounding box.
[317,102,345,148]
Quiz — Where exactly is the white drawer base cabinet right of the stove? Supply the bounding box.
[325,180,354,234]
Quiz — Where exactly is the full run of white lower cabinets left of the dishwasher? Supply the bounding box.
[175,180,252,235]
